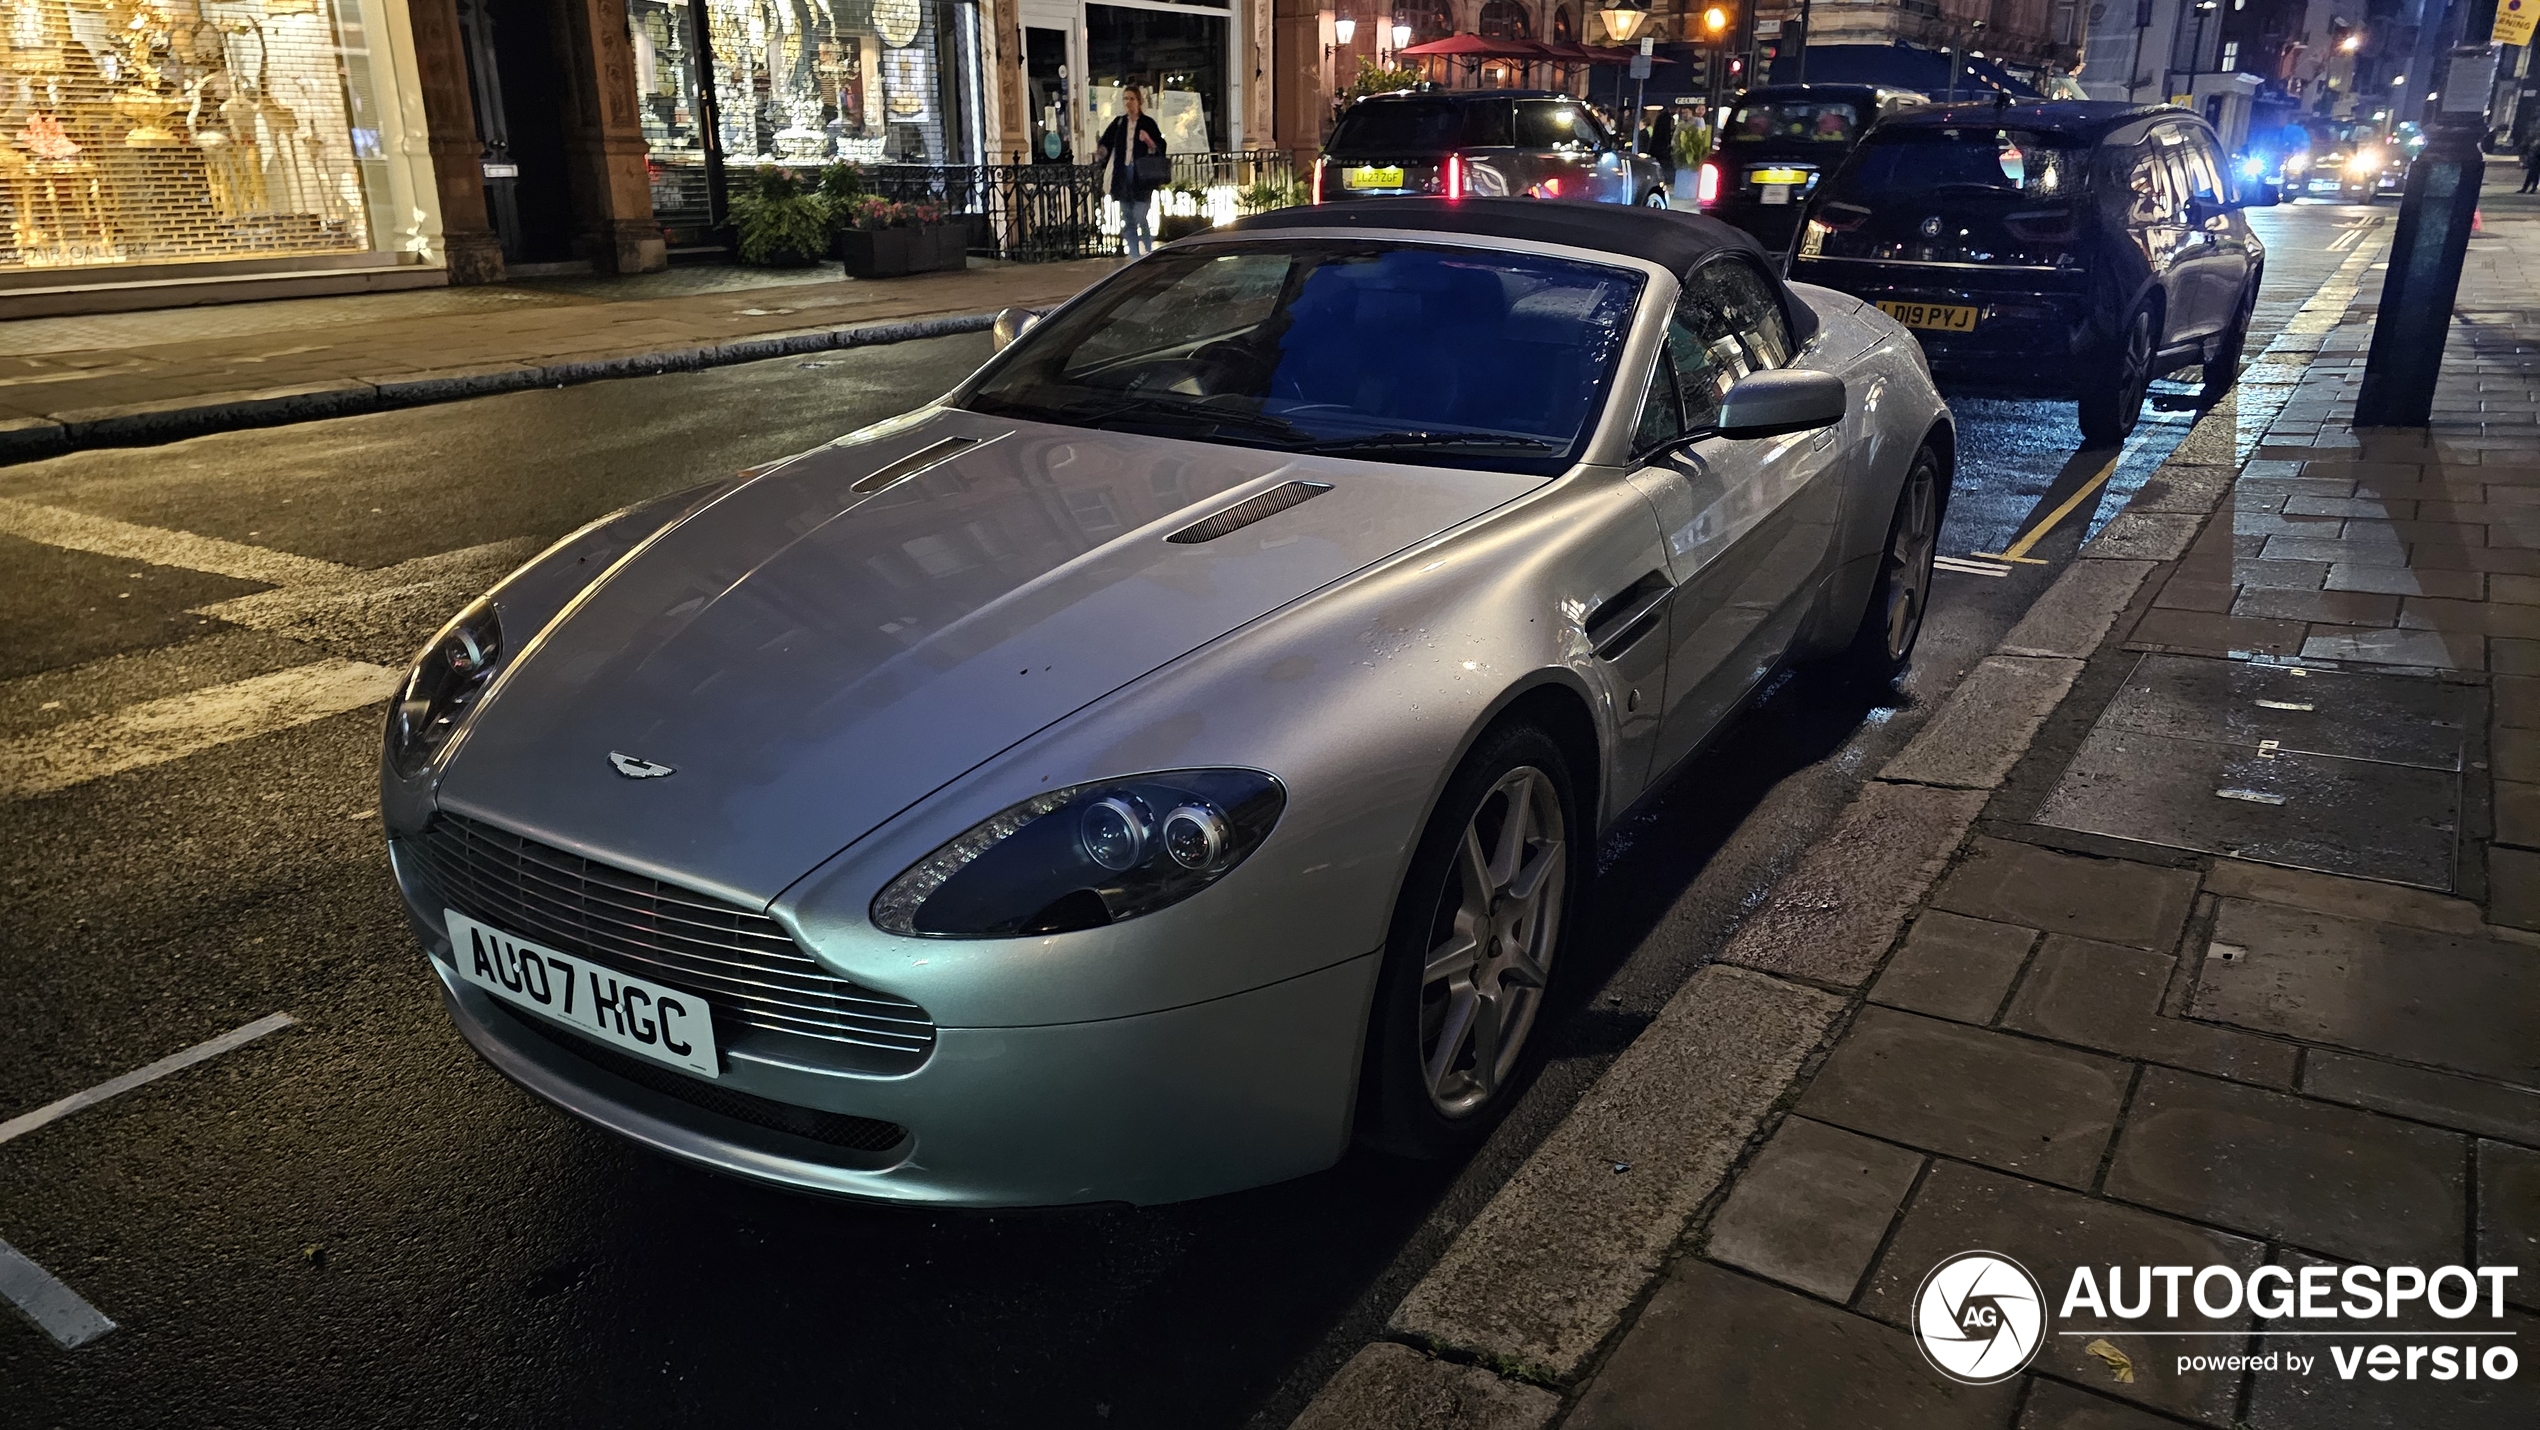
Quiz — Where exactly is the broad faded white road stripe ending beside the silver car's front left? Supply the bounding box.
[0,660,401,800]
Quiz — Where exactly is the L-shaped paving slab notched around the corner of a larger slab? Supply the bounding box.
[2002,935,2299,1087]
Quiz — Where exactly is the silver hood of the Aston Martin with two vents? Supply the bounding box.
[437,411,1544,904]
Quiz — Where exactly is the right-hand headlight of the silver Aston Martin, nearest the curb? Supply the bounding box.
[874,770,1288,937]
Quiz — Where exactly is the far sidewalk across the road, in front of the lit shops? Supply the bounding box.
[0,259,1118,462]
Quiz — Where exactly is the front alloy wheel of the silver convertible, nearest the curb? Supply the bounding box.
[1420,765,1570,1118]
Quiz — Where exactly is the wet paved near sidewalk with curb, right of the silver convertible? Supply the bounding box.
[1295,180,2540,1430]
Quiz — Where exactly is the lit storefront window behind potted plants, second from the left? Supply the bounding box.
[624,0,980,226]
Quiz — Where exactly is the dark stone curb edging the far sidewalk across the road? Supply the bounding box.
[0,312,996,465]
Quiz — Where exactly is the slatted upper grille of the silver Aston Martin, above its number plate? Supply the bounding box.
[399,815,935,1072]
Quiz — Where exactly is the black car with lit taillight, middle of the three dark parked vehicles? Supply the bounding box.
[1694,84,1930,254]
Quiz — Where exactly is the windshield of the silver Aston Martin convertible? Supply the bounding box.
[958,241,1641,475]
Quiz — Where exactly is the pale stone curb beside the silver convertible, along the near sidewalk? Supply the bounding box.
[1293,241,2380,1430]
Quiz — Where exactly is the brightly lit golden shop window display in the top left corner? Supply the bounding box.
[0,0,437,287]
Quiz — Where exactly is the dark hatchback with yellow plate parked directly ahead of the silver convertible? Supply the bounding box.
[1791,102,2266,444]
